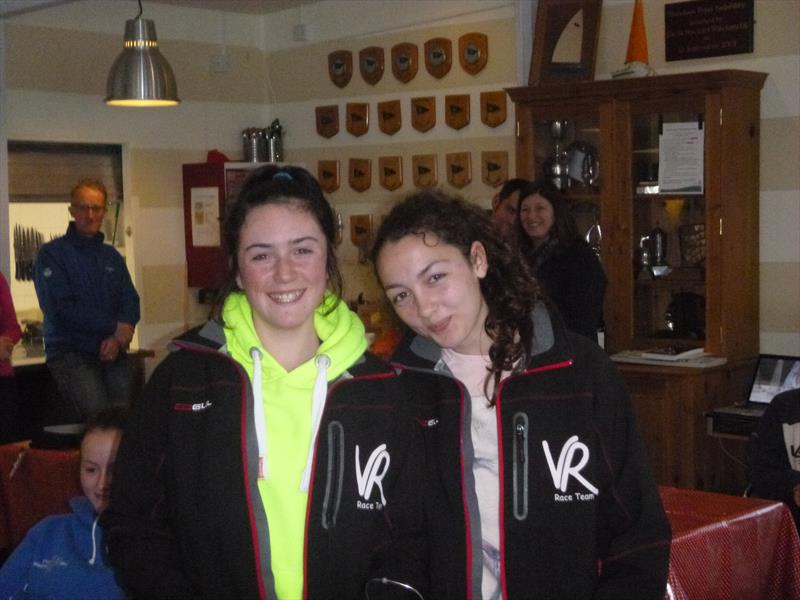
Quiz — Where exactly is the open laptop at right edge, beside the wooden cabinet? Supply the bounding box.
[706,354,800,436]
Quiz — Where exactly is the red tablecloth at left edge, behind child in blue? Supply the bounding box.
[0,442,82,550]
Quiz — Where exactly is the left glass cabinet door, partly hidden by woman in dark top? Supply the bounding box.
[533,111,602,256]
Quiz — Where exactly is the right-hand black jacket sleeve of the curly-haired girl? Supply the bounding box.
[594,350,672,600]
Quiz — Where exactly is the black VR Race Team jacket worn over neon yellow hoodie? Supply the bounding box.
[102,326,427,599]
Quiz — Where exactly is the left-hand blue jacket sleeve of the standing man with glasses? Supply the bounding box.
[34,245,117,336]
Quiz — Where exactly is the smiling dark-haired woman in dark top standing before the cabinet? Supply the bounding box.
[517,181,606,341]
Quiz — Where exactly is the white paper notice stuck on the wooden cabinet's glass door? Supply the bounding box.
[658,121,703,194]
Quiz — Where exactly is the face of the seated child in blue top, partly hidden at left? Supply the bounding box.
[81,429,121,513]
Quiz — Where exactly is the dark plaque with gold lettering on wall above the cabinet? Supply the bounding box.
[664,0,753,61]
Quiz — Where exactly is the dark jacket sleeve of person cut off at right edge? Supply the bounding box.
[750,392,800,506]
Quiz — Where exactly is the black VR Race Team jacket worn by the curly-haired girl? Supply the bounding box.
[393,308,671,600]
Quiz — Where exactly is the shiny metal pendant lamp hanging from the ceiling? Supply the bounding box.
[105,0,180,106]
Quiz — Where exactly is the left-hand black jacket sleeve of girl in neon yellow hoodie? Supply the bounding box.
[101,357,195,598]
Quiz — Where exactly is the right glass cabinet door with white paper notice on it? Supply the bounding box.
[631,112,706,350]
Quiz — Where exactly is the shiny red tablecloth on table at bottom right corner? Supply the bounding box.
[660,487,800,600]
